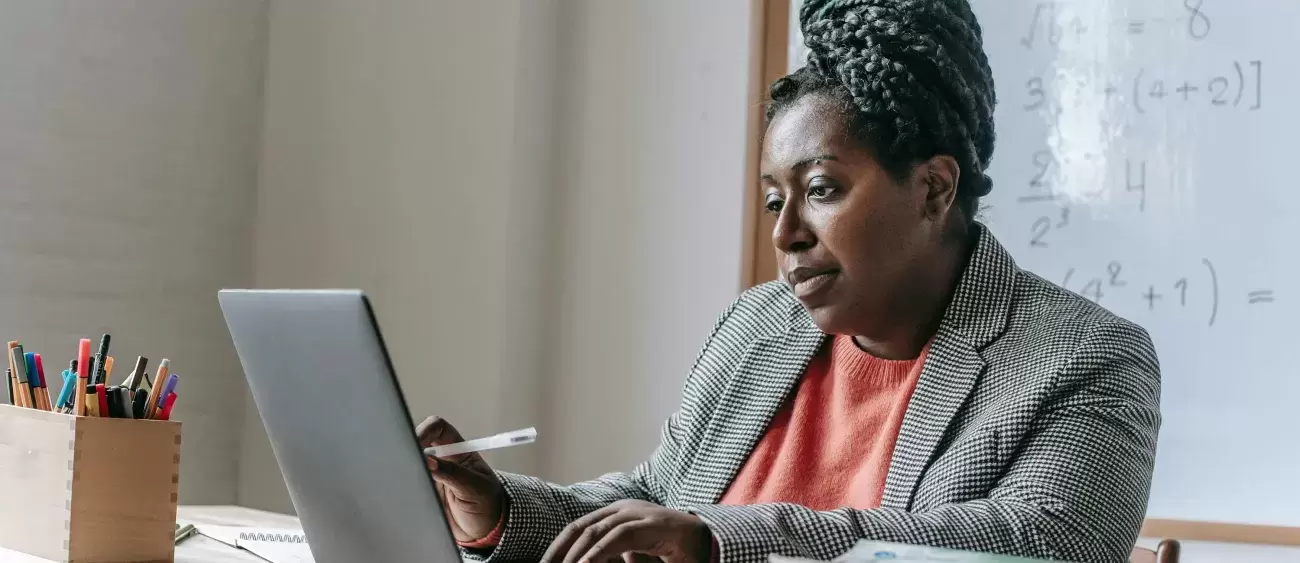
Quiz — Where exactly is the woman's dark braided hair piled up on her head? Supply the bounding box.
[767,0,997,220]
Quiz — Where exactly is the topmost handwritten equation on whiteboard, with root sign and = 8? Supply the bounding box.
[1021,0,1214,49]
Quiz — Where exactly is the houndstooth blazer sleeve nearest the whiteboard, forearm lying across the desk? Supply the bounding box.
[690,322,1160,563]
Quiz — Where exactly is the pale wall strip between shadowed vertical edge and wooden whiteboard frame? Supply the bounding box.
[543,0,750,481]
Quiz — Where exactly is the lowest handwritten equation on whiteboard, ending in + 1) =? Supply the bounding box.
[1061,259,1278,326]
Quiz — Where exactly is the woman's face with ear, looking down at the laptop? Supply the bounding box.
[761,95,957,335]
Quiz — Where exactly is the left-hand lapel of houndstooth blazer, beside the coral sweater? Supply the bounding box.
[683,307,826,506]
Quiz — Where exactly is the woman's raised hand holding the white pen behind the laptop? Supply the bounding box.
[415,416,506,542]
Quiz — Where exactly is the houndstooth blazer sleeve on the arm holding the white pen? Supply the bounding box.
[462,298,744,563]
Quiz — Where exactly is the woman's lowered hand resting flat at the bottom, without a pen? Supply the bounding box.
[542,501,714,563]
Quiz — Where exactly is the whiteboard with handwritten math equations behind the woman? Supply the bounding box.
[790,0,1300,527]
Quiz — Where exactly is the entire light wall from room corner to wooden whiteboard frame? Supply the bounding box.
[239,0,749,510]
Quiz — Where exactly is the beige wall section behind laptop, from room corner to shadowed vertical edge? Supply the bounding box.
[239,0,556,511]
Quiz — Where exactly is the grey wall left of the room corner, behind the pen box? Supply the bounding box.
[0,0,267,503]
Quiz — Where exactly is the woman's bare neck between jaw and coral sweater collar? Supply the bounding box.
[853,221,975,360]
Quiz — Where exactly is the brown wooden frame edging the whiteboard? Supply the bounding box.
[741,0,1300,546]
